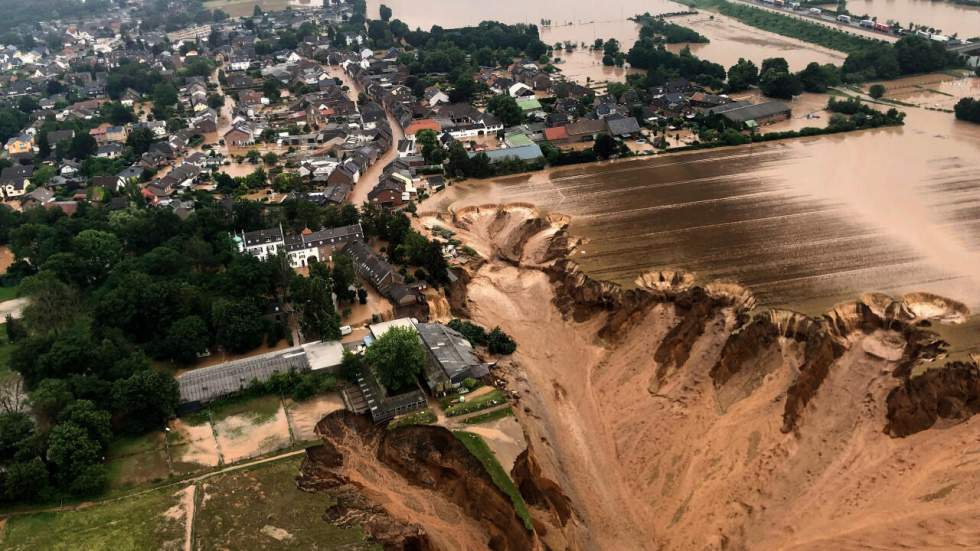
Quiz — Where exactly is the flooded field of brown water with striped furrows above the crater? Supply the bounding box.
[423,88,980,312]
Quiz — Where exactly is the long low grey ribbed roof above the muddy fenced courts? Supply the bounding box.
[177,346,310,404]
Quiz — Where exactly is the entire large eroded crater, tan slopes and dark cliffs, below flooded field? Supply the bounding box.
[446,206,980,550]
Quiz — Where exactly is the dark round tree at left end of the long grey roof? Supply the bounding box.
[112,369,180,434]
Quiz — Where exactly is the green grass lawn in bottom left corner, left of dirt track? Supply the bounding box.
[0,488,185,551]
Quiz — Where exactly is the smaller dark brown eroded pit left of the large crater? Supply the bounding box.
[299,411,533,551]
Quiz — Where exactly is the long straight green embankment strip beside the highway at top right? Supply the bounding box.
[681,0,878,54]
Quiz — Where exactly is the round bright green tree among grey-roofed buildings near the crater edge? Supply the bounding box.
[364,327,426,393]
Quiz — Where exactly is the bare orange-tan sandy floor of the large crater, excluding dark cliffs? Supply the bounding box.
[430,207,980,549]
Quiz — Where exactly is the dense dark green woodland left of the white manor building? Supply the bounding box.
[0,196,344,500]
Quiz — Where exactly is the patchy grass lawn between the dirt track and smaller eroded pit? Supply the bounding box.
[194,458,381,551]
